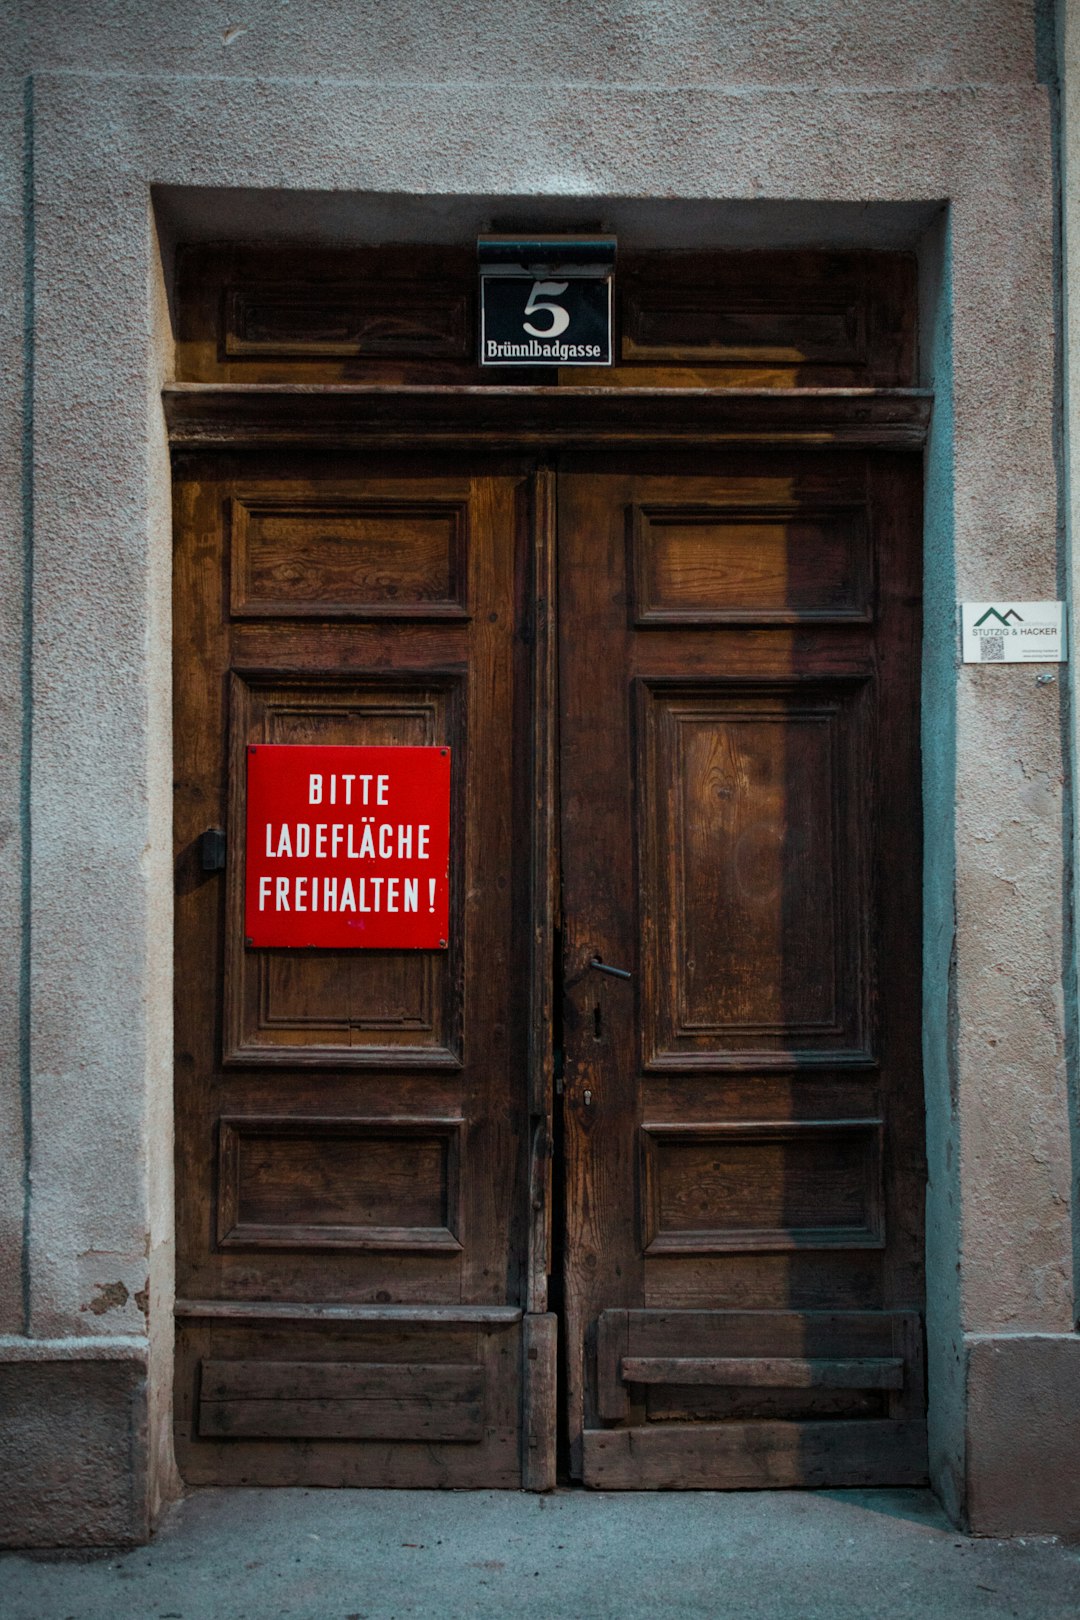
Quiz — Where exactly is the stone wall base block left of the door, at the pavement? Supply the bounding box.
[0,1346,151,1547]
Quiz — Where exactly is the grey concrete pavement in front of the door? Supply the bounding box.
[0,1490,1080,1620]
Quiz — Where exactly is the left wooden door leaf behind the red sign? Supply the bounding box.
[175,454,529,1486]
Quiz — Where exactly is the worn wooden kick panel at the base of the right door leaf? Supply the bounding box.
[583,1311,926,1490]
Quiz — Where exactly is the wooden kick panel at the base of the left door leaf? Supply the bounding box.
[176,1302,521,1487]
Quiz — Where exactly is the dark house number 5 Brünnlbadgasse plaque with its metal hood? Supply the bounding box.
[476,235,615,366]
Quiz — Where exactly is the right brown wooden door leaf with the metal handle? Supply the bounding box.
[559,449,925,1489]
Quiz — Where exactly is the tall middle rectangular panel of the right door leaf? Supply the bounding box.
[638,680,873,1069]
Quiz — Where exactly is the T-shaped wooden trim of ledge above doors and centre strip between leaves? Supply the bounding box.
[164,382,933,1490]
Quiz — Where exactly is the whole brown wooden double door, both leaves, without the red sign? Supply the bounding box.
[175,446,925,1489]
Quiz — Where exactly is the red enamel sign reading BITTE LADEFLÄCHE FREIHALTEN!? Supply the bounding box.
[244,742,450,951]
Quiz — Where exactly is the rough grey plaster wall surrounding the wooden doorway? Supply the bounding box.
[0,0,1074,1542]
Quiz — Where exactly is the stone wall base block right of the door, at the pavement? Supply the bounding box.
[967,1333,1080,1536]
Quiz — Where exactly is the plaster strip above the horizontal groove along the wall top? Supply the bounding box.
[4,0,1035,89]
